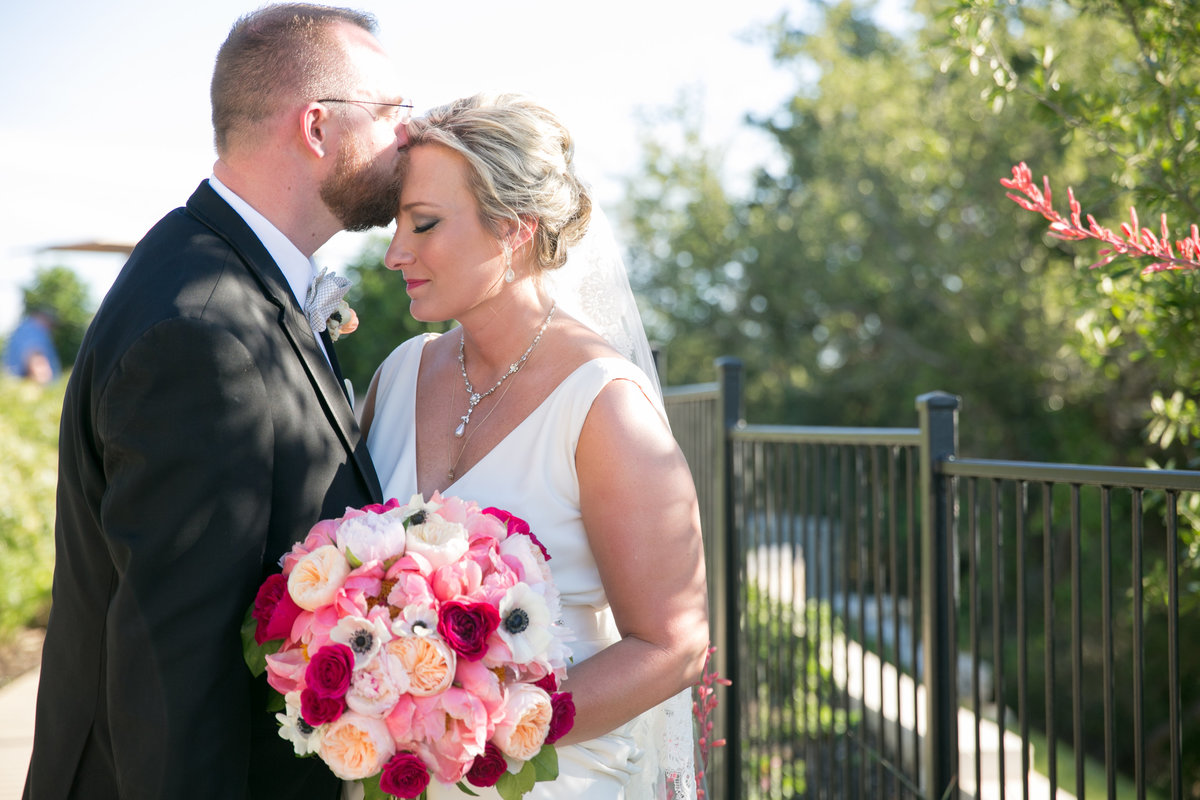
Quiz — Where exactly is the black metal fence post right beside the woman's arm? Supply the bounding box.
[709,356,745,800]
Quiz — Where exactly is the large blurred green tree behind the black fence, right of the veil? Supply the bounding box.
[630,2,1136,461]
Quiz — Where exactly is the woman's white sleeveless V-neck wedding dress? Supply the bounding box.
[355,335,696,800]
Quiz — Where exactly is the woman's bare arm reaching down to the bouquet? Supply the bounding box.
[560,380,708,744]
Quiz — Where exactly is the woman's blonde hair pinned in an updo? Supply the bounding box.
[408,94,592,273]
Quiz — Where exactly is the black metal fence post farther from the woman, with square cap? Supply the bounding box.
[917,392,959,800]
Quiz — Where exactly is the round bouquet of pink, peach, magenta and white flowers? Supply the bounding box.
[242,494,575,800]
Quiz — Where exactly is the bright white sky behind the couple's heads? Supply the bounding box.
[0,0,912,336]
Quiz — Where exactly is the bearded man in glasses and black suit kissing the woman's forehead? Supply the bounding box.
[24,5,406,800]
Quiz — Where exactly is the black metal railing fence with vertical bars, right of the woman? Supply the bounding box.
[666,360,1200,800]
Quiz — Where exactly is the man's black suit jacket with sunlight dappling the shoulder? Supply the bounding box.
[25,181,380,800]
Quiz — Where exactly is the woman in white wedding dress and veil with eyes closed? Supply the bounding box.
[357,95,708,800]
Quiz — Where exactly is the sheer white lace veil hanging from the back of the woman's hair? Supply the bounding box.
[542,206,696,800]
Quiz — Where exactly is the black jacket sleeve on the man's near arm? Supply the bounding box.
[96,319,274,799]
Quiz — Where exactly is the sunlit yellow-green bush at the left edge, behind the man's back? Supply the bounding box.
[0,375,66,640]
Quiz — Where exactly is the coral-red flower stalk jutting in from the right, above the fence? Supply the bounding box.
[1000,161,1200,273]
